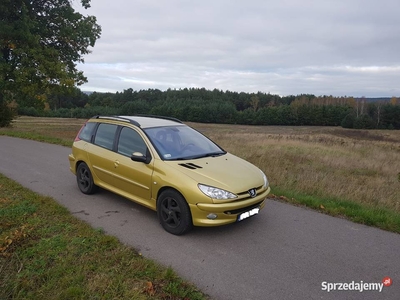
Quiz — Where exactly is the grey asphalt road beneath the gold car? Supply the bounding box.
[0,136,400,300]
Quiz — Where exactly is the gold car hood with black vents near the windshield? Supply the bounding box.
[165,153,264,193]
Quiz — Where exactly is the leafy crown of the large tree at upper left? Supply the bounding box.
[0,0,101,125]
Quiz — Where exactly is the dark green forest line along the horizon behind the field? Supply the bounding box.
[16,88,400,129]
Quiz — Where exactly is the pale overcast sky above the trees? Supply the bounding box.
[75,0,400,97]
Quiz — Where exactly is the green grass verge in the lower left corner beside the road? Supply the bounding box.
[0,174,207,299]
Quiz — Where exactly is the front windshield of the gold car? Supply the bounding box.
[144,125,226,160]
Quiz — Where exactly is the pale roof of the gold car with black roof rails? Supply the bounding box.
[94,115,183,128]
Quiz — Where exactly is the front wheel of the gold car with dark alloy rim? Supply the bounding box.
[157,190,193,235]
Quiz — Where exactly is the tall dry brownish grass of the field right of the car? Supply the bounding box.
[191,124,400,212]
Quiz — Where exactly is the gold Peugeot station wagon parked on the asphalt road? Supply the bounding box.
[69,116,270,235]
